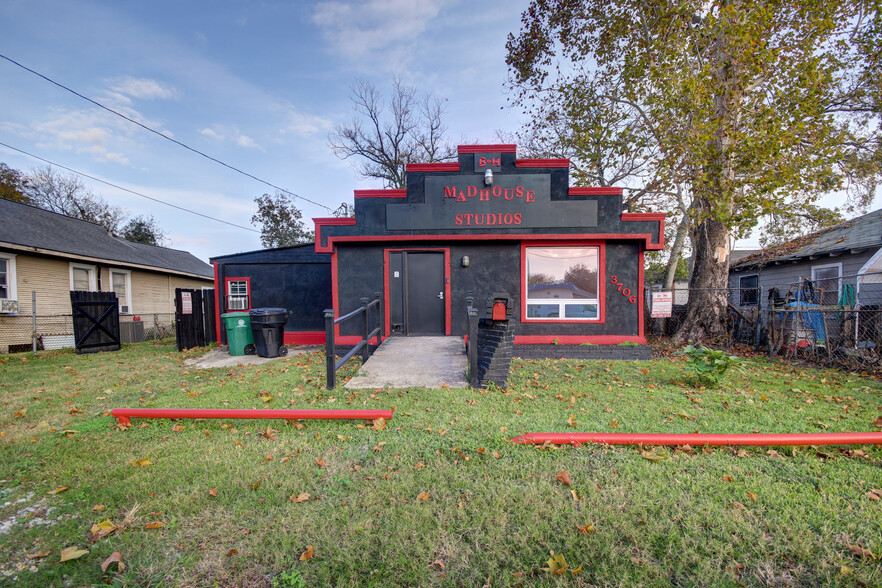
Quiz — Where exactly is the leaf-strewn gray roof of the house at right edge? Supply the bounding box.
[732,209,882,267]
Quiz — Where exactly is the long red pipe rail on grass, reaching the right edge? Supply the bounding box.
[510,432,882,446]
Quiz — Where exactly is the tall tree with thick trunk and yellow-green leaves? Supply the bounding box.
[507,0,882,340]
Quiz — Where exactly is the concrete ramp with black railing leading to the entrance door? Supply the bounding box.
[345,337,468,388]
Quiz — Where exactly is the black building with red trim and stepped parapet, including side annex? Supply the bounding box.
[212,145,665,346]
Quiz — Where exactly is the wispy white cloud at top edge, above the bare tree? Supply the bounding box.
[312,0,443,61]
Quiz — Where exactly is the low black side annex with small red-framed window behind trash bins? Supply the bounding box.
[211,243,331,345]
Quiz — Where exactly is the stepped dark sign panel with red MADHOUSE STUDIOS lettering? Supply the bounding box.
[386,174,597,231]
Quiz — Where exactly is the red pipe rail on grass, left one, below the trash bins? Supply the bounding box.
[110,408,392,425]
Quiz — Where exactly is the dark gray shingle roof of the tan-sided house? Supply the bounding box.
[0,198,214,278]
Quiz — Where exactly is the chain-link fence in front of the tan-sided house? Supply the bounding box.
[0,309,175,353]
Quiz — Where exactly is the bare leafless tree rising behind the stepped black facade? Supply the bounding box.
[328,78,456,188]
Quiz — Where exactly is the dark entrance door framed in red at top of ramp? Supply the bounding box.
[389,251,447,335]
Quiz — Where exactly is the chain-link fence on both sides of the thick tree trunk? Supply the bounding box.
[645,272,882,371]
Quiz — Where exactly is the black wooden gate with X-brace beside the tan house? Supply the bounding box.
[70,291,120,353]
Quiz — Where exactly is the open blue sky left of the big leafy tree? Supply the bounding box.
[0,0,528,261]
